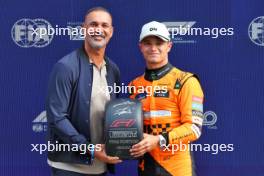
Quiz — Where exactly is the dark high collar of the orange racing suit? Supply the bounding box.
[144,63,173,81]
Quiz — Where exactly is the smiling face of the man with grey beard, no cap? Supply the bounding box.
[84,10,113,49]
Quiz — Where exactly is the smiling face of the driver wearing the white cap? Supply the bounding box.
[139,36,172,69]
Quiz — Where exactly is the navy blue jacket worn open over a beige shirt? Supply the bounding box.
[46,48,120,172]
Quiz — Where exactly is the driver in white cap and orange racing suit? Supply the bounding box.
[129,21,203,176]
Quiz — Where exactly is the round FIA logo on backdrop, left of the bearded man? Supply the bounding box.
[11,18,53,48]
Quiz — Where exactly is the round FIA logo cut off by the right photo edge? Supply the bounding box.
[248,16,264,46]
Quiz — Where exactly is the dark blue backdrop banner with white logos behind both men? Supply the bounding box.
[0,0,264,176]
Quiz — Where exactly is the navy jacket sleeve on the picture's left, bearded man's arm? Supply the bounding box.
[46,63,88,145]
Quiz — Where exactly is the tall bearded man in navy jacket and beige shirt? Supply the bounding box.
[46,7,121,176]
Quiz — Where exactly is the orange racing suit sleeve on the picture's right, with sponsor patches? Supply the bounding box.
[165,77,204,144]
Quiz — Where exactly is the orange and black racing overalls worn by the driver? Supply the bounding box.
[129,63,204,176]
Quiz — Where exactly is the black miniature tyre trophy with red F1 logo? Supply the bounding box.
[105,99,143,160]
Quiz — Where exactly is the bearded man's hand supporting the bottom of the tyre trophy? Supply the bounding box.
[94,144,122,164]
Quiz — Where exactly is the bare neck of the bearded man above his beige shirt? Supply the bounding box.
[84,42,105,68]
